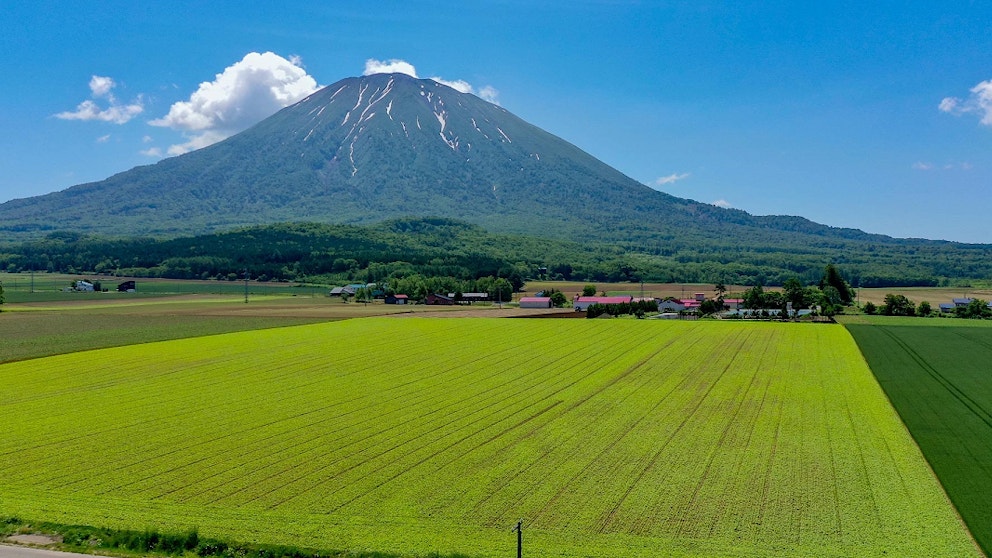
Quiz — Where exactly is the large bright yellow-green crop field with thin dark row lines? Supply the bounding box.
[0,318,979,557]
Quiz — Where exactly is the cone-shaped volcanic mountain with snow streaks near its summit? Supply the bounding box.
[0,74,992,282]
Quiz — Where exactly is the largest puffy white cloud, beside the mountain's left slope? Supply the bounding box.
[149,52,318,155]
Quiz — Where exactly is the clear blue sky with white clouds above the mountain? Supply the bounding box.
[0,0,992,243]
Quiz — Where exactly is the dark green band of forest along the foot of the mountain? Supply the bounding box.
[0,218,992,292]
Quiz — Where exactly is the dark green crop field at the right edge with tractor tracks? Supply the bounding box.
[847,317,992,553]
